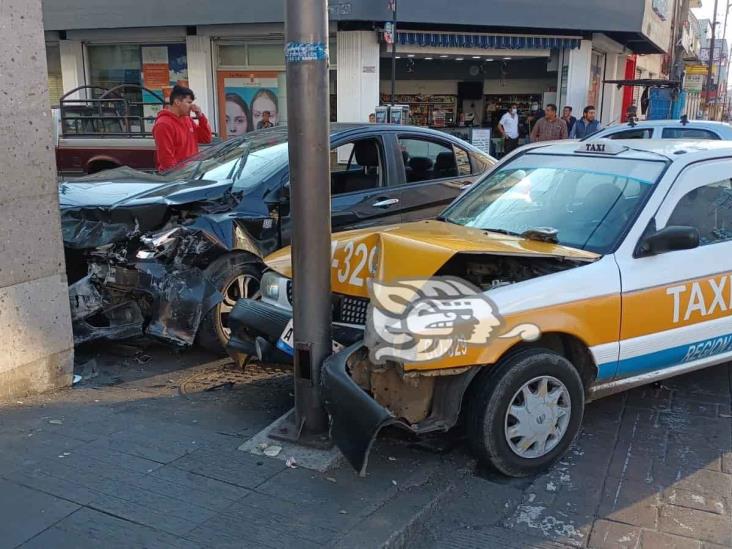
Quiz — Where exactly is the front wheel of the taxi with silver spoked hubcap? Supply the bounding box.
[466,349,585,477]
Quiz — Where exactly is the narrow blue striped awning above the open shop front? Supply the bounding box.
[382,31,582,50]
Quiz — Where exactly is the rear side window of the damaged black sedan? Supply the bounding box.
[396,138,458,184]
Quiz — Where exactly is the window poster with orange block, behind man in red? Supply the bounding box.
[141,44,188,131]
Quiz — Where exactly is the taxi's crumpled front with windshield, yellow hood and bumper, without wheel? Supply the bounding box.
[244,142,669,472]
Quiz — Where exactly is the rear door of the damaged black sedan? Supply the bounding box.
[388,133,478,221]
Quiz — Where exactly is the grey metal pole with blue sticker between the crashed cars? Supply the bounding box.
[285,0,332,441]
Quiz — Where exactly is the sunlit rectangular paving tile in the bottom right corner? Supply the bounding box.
[659,505,732,545]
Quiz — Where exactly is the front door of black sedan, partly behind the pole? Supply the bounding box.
[280,133,401,246]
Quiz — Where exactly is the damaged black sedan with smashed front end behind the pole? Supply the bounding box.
[59,124,494,352]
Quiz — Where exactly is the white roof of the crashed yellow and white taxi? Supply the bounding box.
[526,138,732,161]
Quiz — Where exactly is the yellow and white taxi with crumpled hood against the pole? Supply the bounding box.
[230,140,732,476]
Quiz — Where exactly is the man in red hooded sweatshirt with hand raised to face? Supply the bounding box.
[153,86,211,172]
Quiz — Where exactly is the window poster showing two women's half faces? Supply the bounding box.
[218,71,284,138]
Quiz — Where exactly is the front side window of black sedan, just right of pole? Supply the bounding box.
[330,138,384,196]
